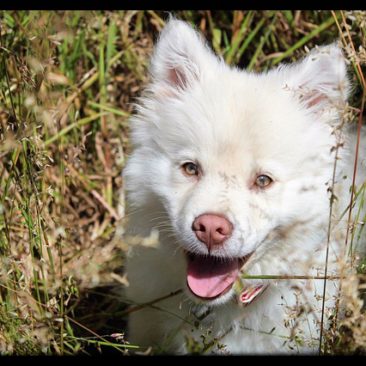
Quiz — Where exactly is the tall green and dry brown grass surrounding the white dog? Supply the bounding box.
[0,11,366,355]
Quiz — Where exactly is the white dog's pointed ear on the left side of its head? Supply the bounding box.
[150,18,218,91]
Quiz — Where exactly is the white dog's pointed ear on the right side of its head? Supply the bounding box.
[283,43,350,111]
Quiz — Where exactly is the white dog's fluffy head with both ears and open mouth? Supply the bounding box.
[125,21,347,300]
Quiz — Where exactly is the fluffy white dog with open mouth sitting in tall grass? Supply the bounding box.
[124,19,364,354]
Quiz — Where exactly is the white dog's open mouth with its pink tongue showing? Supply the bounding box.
[187,255,239,298]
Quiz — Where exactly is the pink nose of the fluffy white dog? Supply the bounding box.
[192,214,233,251]
